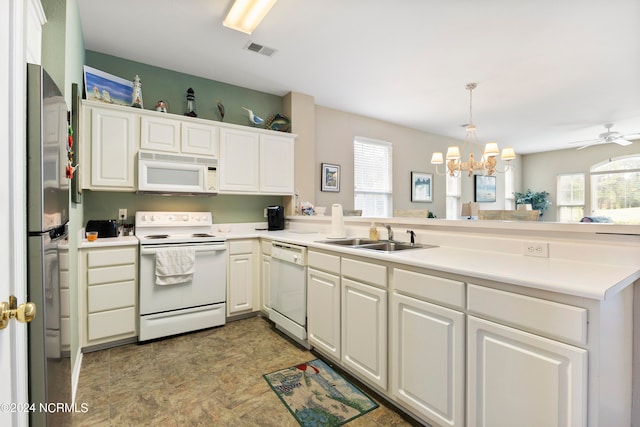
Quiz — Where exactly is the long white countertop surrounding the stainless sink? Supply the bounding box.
[225,230,640,300]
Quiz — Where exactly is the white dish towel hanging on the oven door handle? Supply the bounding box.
[156,248,196,285]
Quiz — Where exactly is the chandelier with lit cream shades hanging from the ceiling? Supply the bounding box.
[431,83,516,176]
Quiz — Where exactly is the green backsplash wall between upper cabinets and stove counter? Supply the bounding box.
[82,190,283,226]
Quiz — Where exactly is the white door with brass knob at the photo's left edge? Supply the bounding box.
[0,0,28,426]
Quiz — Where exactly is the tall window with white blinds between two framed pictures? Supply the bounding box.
[353,136,393,217]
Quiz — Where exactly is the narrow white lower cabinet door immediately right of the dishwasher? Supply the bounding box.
[307,268,340,360]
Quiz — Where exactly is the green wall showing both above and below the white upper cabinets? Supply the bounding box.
[83,50,283,225]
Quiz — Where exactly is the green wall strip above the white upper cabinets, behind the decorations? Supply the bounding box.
[86,50,283,126]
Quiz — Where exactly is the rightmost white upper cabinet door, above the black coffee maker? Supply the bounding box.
[260,135,294,194]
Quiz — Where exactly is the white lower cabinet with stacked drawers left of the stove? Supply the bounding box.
[79,246,138,347]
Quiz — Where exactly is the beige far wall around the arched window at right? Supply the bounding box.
[520,142,640,221]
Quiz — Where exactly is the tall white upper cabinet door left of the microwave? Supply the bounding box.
[90,108,137,190]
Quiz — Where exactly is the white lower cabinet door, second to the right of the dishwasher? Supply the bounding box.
[341,277,387,389]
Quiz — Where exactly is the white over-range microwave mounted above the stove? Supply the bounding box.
[138,151,218,196]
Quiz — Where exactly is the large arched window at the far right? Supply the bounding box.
[591,155,640,224]
